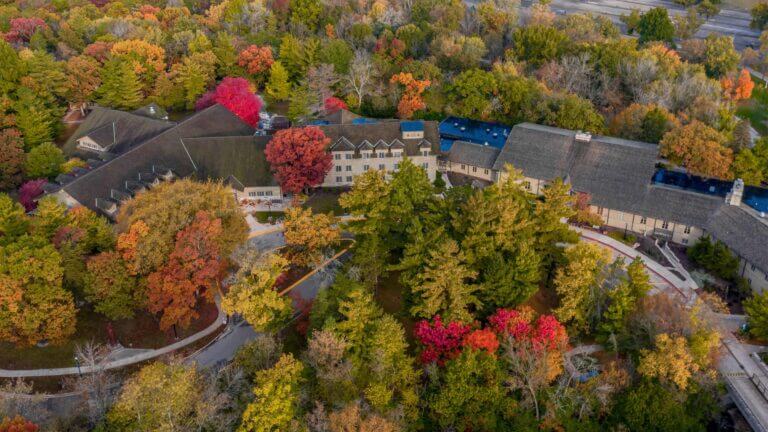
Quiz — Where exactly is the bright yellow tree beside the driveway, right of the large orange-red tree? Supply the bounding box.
[221,250,293,331]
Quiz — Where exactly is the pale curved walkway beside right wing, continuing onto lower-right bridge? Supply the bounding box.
[574,227,768,432]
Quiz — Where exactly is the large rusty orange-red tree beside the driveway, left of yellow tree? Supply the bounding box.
[147,211,224,330]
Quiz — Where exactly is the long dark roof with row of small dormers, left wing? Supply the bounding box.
[64,105,254,210]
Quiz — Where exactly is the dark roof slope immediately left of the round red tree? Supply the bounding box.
[182,136,277,191]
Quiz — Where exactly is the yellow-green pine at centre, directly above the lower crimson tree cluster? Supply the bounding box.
[411,240,480,322]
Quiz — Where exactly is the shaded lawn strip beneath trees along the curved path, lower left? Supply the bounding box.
[0,304,218,370]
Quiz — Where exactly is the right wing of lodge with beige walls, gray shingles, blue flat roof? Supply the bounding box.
[443,123,768,291]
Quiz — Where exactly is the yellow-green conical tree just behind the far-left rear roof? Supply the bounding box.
[98,59,144,110]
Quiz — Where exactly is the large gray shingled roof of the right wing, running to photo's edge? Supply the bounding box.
[486,123,768,272]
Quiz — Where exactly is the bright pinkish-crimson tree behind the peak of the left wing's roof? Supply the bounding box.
[195,77,261,126]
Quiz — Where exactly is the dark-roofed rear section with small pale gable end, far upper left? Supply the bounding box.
[62,106,175,159]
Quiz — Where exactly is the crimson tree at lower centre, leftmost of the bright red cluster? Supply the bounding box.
[413,315,470,365]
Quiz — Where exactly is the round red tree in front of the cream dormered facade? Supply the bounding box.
[265,126,332,193]
